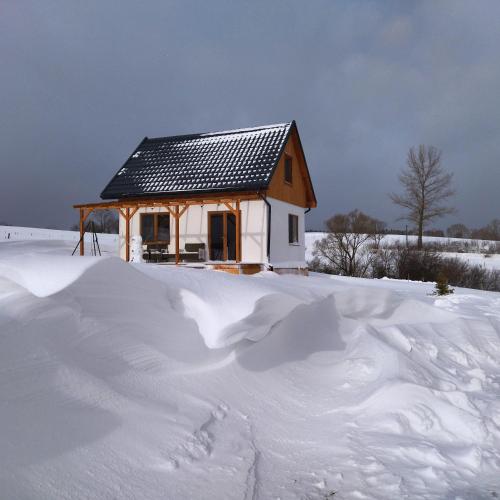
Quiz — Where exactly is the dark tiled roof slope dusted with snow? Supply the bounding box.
[101,122,295,199]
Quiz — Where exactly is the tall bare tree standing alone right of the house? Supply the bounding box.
[389,144,455,249]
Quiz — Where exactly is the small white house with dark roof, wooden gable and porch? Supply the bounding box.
[75,121,316,273]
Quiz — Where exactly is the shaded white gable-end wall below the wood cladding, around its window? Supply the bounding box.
[267,198,306,268]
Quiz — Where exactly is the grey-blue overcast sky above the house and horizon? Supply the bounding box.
[0,0,500,228]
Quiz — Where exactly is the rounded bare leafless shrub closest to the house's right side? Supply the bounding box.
[313,210,384,276]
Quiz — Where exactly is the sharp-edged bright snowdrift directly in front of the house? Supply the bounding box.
[136,264,331,348]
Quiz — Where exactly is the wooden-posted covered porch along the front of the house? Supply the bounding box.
[74,193,265,272]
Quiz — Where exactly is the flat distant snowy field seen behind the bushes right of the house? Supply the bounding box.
[306,232,500,269]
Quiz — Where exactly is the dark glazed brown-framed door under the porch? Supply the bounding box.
[208,212,236,260]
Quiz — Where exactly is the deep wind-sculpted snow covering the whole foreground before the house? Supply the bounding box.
[0,236,500,500]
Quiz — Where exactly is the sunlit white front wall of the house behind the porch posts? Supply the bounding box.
[120,200,268,263]
